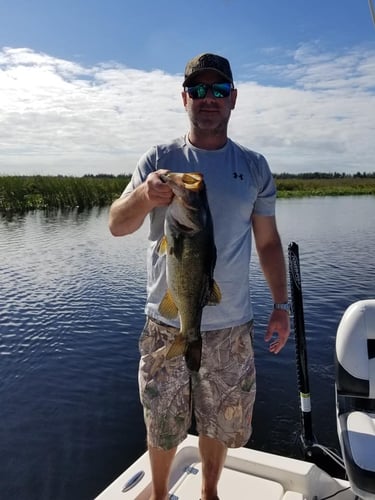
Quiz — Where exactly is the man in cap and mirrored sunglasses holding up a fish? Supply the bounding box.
[109,54,290,500]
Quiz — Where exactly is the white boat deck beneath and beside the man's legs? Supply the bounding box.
[96,435,356,500]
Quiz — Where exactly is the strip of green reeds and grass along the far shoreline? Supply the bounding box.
[0,172,375,213]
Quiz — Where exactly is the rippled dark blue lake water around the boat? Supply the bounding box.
[0,196,375,500]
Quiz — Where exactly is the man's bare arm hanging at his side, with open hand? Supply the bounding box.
[252,215,290,354]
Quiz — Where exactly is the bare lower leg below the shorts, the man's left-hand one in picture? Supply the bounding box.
[148,446,177,500]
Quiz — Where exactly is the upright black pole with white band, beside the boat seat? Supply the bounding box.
[288,242,344,474]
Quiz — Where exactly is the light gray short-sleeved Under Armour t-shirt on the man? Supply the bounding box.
[123,137,276,331]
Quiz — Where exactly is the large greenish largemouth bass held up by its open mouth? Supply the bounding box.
[159,172,221,371]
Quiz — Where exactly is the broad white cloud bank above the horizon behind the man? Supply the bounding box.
[0,44,375,175]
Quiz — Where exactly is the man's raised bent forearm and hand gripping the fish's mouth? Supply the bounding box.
[109,170,173,236]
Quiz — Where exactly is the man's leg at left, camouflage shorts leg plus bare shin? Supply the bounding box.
[138,319,191,500]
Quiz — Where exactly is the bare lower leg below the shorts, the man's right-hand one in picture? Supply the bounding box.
[199,436,227,500]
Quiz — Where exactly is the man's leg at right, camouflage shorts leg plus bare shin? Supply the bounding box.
[192,322,256,500]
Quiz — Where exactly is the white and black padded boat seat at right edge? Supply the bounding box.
[335,299,375,500]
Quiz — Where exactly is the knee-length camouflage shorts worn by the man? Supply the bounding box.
[139,318,256,449]
